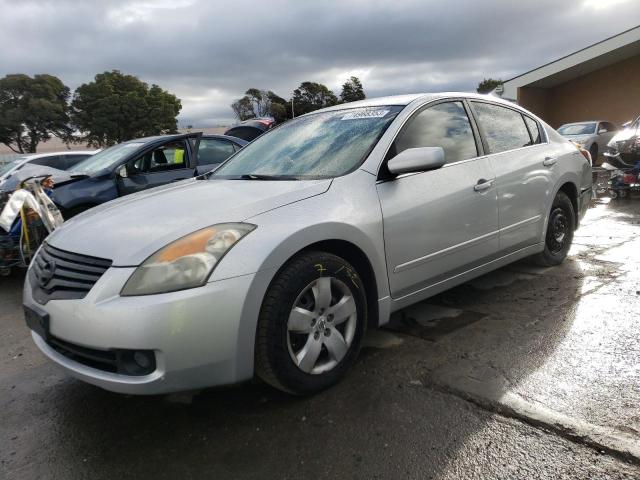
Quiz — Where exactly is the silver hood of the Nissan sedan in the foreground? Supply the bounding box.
[47,179,331,266]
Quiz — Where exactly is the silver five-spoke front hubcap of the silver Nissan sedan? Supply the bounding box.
[287,277,358,375]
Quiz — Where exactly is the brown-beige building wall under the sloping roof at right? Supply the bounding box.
[518,55,640,128]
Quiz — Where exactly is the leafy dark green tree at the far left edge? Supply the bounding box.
[0,74,71,153]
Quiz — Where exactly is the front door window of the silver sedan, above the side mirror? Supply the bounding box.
[392,102,478,163]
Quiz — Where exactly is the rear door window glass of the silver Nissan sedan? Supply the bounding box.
[472,102,531,153]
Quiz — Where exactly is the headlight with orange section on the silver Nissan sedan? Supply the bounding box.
[120,223,256,296]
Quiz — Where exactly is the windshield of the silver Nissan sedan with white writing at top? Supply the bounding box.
[211,106,403,179]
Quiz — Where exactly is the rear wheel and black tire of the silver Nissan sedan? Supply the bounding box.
[533,192,576,267]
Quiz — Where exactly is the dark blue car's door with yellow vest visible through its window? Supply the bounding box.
[117,133,201,196]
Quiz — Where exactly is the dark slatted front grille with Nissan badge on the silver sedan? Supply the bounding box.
[29,243,111,304]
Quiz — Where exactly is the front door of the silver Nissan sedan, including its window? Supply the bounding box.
[377,100,498,299]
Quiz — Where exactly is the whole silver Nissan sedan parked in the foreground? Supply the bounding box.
[24,94,591,394]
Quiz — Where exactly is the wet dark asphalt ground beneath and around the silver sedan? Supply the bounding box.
[0,198,640,479]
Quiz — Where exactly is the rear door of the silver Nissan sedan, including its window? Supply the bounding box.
[470,100,557,255]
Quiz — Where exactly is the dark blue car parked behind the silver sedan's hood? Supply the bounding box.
[52,133,248,218]
